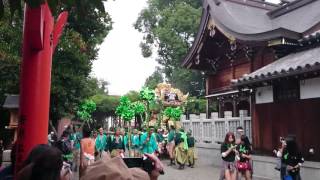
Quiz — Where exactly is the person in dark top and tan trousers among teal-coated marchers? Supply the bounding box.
[109,128,125,158]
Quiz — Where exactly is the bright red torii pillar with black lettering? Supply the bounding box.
[16,3,68,172]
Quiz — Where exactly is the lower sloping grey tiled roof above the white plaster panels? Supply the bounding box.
[234,47,320,85]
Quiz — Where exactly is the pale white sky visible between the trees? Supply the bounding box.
[93,0,157,95]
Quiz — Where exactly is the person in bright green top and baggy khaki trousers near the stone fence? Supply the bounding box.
[175,128,188,169]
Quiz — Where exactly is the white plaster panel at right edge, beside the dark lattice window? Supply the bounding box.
[300,78,320,99]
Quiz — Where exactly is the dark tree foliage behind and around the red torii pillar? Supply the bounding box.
[0,0,112,125]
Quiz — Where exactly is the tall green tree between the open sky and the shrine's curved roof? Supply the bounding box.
[135,0,204,96]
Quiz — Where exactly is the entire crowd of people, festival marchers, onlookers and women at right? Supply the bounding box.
[0,126,304,180]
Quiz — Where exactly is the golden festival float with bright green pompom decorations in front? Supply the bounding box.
[116,83,188,129]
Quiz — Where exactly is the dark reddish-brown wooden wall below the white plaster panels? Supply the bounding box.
[252,98,320,161]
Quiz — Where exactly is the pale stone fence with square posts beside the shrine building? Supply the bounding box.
[181,110,252,148]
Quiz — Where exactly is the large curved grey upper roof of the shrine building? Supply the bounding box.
[182,0,320,70]
